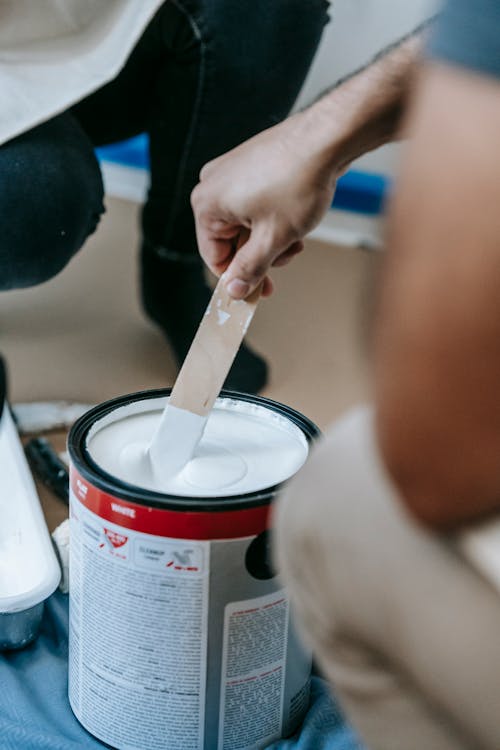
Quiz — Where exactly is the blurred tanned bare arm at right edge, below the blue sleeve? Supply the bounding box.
[375,65,500,528]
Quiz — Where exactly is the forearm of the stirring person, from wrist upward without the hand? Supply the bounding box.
[303,24,428,173]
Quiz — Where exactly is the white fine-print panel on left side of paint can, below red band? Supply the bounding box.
[69,496,210,750]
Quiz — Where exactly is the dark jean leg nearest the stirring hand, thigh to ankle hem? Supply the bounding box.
[143,0,329,253]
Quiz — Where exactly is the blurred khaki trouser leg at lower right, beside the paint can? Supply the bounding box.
[276,410,500,750]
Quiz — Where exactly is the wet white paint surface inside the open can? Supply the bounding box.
[87,398,308,497]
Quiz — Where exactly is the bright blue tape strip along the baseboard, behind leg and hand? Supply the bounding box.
[97,133,391,216]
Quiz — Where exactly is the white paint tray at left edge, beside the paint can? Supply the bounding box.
[0,409,61,651]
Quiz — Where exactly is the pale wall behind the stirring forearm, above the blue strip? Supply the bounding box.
[297,0,439,173]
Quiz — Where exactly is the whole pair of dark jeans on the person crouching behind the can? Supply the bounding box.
[0,0,329,289]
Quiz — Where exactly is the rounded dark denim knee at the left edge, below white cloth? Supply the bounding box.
[0,114,104,290]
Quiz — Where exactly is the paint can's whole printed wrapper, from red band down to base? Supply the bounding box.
[69,470,310,750]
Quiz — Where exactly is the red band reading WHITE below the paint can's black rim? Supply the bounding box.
[70,467,269,540]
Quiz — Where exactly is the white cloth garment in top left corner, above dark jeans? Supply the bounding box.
[0,0,163,143]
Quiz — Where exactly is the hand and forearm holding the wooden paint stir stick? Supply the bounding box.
[192,34,421,298]
